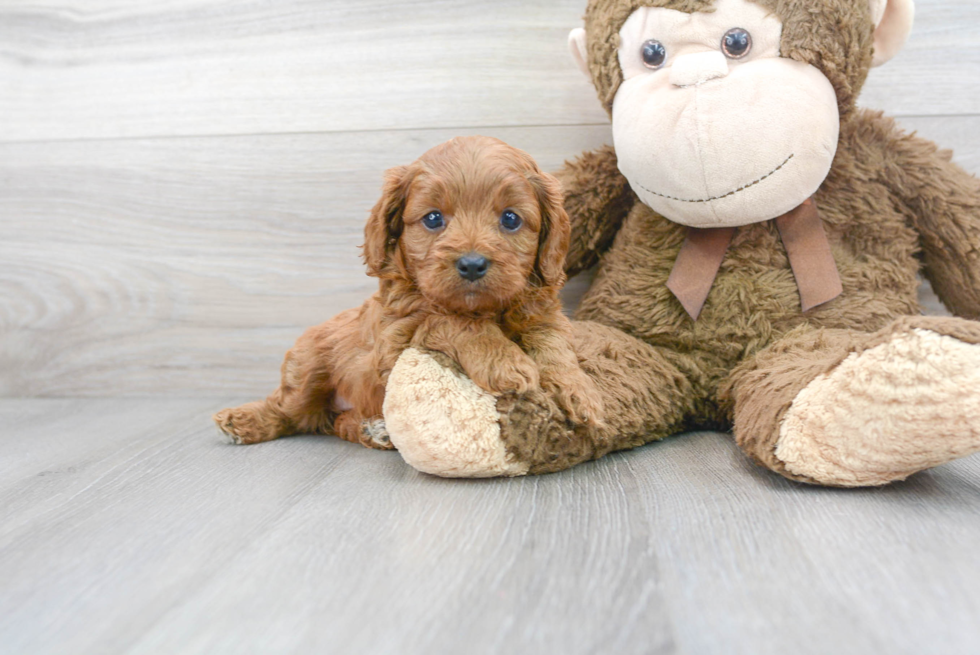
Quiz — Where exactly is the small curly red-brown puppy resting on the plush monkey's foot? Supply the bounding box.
[214,137,601,448]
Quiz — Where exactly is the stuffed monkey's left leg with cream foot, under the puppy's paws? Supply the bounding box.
[384,321,692,477]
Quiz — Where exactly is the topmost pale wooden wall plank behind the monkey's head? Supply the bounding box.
[0,0,980,141]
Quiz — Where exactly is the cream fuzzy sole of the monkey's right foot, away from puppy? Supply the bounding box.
[776,329,980,487]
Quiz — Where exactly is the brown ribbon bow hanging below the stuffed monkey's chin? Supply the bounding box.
[667,198,844,320]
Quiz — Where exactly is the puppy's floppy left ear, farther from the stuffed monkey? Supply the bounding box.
[362,166,416,277]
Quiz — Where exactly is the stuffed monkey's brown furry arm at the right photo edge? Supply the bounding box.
[888,126,980,319]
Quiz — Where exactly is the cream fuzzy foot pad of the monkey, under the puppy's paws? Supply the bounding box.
[384,348,529,478]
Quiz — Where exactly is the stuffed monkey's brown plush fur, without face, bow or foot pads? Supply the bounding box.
[482,0,980,482]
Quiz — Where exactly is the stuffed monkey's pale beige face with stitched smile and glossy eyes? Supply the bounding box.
[612,0,840,227]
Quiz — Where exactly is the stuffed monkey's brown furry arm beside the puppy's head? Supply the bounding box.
[555,146,636,276]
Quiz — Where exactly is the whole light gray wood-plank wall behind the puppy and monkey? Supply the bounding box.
[0,0,980,397]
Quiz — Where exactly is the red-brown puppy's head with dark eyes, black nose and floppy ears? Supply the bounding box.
[364,137,570,313]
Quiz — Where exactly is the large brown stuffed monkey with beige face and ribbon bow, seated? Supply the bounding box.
[385,0,980,487]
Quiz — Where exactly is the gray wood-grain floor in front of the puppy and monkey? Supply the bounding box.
[0,399,980,655]
